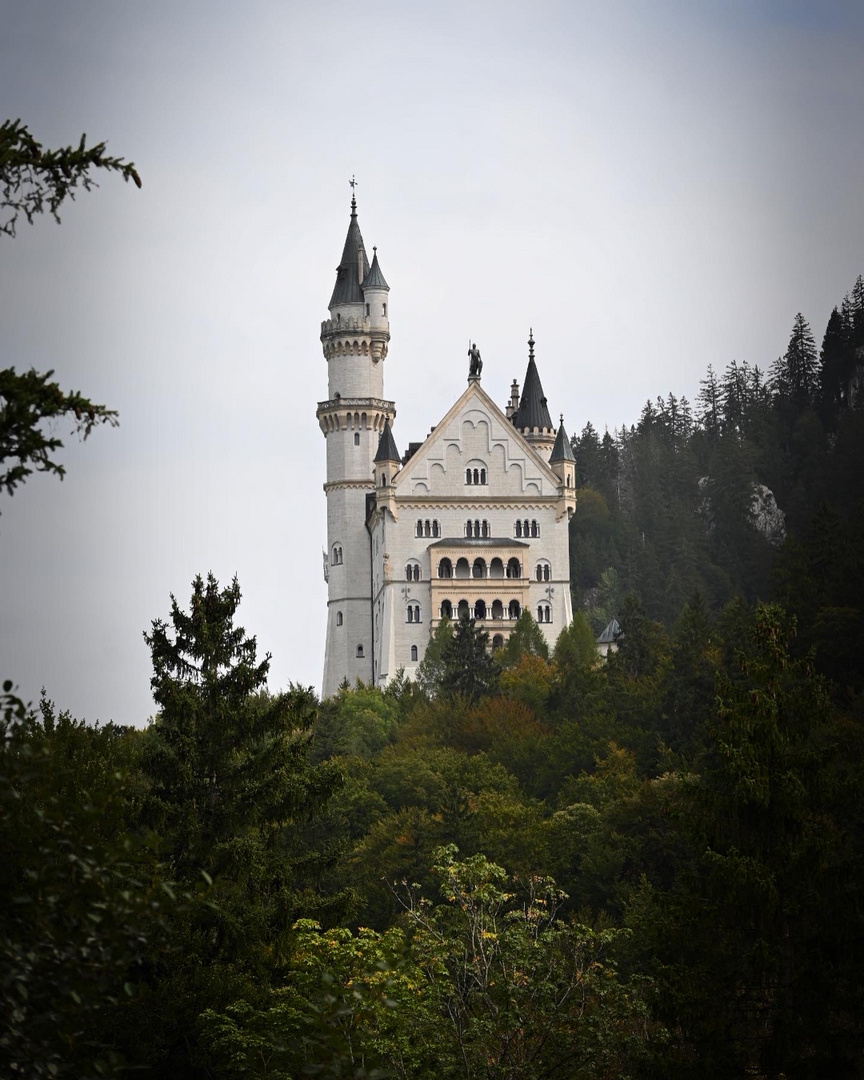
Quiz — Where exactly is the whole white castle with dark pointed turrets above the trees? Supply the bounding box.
[316,197,576,698]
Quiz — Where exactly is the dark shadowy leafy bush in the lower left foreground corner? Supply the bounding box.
[0,683,173,1080]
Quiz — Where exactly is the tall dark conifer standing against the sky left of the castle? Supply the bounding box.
[143,573,337,876]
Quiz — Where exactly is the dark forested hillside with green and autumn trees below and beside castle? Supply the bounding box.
[0,279,864,1080]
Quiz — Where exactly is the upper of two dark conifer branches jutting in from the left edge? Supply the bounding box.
[0,120,141,237]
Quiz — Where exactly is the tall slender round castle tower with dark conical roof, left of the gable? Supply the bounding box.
[316,195,396,698]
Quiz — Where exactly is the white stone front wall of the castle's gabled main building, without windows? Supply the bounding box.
[373,392,572,683]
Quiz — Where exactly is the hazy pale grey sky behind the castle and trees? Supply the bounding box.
[0,0,864,724]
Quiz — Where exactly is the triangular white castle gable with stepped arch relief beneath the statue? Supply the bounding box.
[395,381,558,499]
